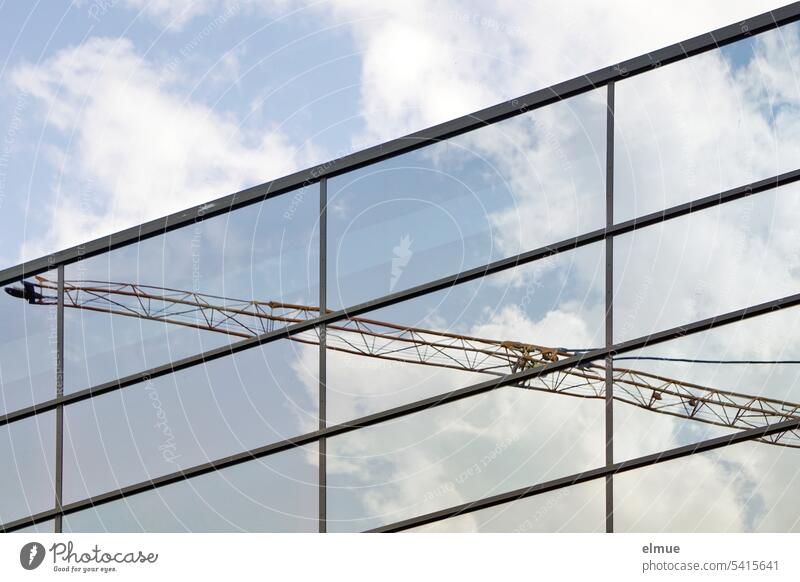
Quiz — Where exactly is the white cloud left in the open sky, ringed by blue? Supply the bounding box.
[12,38,301,258]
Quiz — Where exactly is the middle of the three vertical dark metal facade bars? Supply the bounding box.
[318,178,328,533]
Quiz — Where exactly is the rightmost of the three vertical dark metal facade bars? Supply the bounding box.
[605,82,614,533]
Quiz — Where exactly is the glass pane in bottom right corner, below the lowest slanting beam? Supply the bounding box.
[614,442,800,532]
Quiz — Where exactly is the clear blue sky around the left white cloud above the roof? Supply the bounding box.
[0,3,359,265]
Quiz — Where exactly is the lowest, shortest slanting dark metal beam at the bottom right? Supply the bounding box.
[368,418,800,533]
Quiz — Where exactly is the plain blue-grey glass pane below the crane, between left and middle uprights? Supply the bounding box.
[64,340,318,503]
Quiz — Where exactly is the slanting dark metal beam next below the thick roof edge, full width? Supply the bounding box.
[0,169,800,426]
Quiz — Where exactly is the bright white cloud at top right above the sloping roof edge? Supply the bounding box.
[126,0,782,144]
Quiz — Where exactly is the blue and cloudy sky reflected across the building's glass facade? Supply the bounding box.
[0,19,800,531]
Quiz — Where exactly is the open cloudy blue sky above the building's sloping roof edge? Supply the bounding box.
[0,0,778,266]
